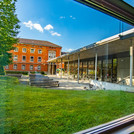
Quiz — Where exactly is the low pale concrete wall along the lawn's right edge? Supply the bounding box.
[90,80,134,92]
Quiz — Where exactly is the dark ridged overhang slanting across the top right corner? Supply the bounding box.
[75,0,134,26]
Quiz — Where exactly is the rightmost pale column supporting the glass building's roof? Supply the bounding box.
[130,46,133,86]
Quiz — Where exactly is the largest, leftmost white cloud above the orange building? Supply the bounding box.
[23,21,43,32]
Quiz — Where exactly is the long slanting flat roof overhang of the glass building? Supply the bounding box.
[47,28,134,63]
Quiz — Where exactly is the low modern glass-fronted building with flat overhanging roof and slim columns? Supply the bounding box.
[48,29,134,90]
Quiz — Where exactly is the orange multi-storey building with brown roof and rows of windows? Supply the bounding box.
[5,38,62,72]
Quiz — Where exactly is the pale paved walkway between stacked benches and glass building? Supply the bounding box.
[47,75,89,90]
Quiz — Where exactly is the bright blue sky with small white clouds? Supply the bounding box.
[16,0,134,52]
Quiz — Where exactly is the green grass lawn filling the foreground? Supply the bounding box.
[0,77,134,134]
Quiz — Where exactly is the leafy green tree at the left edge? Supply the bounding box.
[0,0,20,75]
